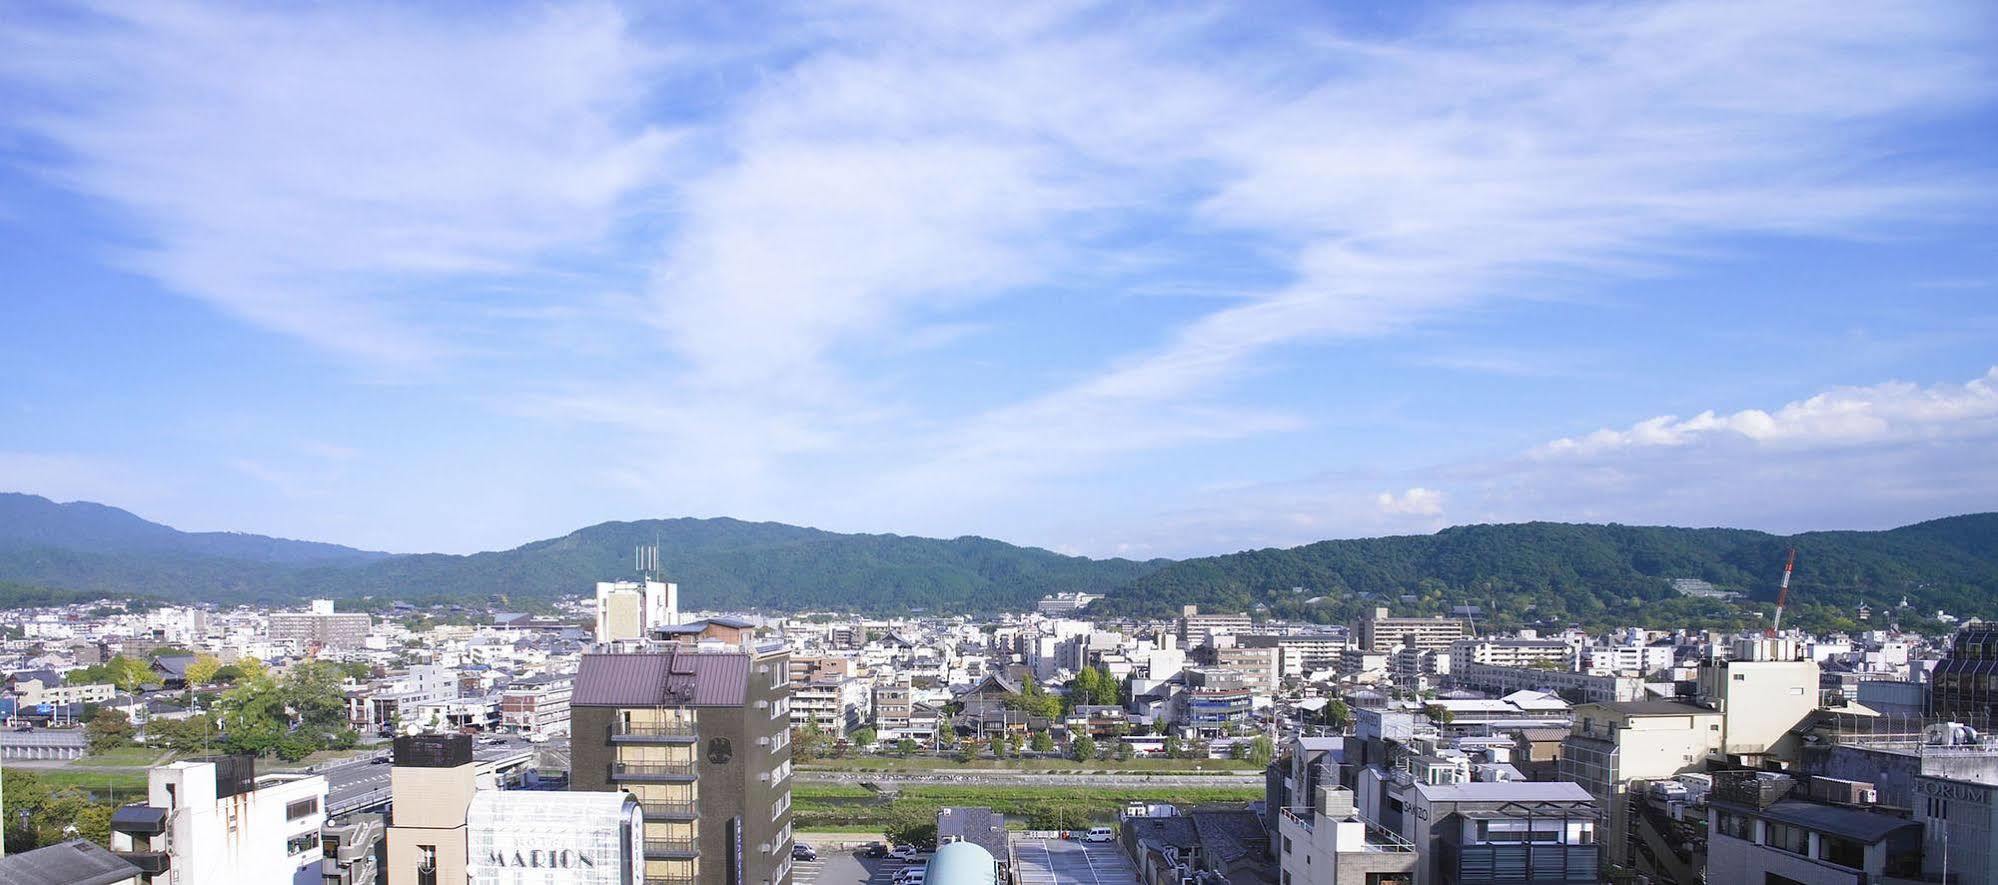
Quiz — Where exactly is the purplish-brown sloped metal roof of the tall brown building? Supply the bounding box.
[569,651,749,707]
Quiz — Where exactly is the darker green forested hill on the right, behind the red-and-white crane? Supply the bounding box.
[1093,513,1998,625]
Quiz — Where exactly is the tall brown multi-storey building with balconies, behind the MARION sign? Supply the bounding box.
[569,643,791,885]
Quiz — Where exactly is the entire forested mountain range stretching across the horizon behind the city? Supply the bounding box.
[0,495,1998,629]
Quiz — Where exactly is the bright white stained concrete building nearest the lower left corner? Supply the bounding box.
[112,755,326,885]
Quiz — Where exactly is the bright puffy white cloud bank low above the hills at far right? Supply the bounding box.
[1532,368,1998,457]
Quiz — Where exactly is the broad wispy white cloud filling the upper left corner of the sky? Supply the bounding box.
[0,2,671,368]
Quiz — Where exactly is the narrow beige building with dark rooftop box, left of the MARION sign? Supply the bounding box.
[388,735,478,885]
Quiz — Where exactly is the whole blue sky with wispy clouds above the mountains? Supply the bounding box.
[0,2,1998,555]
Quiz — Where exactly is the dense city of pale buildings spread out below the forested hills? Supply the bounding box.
[0,549,1998,885]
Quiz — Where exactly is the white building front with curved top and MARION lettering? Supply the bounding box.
[466,789,645,885]
